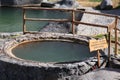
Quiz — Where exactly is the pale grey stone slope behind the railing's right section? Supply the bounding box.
[77,7,120,35]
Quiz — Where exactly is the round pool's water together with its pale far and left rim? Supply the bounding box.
[4,33,96,62]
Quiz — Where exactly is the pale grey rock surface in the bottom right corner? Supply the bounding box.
[79,69,120,80]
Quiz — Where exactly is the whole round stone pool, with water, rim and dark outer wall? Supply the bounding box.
[0,33,104,80]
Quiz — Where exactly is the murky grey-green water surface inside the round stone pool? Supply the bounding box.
[12,40,95,62]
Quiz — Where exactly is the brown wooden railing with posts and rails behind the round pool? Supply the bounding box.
[23,7,120,55]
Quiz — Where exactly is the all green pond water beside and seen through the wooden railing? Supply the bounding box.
[0,7,70,32]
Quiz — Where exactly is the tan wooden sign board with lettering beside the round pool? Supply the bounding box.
[89,39,108,52]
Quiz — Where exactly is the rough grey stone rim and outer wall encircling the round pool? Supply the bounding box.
[0,33,106,80]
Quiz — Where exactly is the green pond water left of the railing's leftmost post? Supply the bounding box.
[0,7,22,32]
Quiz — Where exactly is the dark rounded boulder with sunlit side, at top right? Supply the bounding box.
[100,0,113,9]
